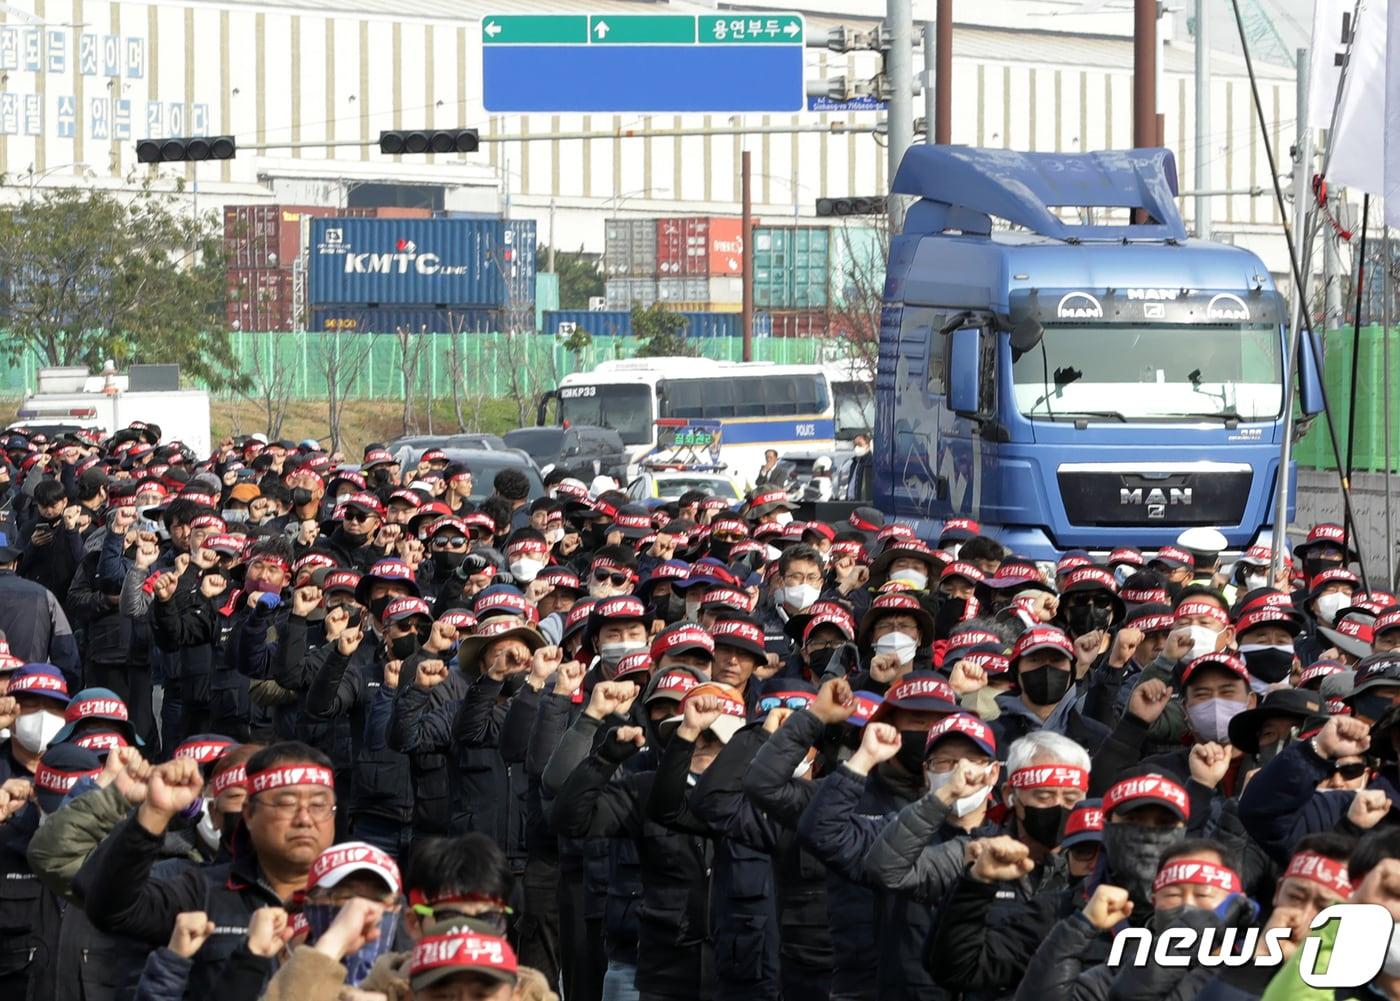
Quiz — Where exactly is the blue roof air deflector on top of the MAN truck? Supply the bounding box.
[892,146,1186,241]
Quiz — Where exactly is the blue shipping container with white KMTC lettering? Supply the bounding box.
[307,218,535,308]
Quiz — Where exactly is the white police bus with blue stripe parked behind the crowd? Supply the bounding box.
[539,358,836,483]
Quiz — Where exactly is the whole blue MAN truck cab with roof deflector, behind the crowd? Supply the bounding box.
[872,146,1322,560]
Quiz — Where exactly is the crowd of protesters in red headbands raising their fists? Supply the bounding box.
[0,426,1400,1001]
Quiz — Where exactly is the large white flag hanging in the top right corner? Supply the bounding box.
[1327,0,1383,195]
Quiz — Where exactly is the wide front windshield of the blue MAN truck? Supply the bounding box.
[1012,323,1284,420]
